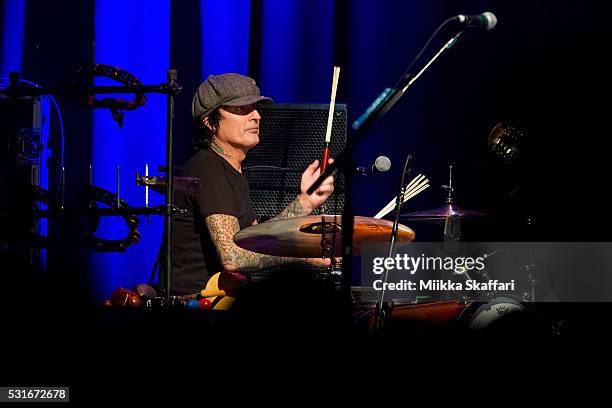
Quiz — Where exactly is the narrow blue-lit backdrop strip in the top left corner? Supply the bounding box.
[0,0,26,77]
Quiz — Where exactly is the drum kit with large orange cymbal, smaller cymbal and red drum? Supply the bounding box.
[234,174,531,331]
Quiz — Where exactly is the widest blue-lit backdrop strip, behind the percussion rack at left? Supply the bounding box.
[91,0,170,299]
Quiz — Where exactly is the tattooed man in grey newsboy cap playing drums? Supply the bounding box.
[172,74,334,295]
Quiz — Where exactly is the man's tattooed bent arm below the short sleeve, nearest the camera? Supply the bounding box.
[206,214,298,272]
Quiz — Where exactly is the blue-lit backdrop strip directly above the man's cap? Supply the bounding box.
[200,0,251,79]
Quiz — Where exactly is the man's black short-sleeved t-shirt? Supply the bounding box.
[172,150,256,295]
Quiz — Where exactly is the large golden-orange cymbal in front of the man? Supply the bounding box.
[234,215,414,258]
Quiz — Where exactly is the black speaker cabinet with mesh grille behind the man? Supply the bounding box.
[242,104,347,222]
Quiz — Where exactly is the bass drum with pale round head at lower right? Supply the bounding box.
[457,295,541,334]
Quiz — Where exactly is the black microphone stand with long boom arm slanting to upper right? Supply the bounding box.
[307,28,463,310]
